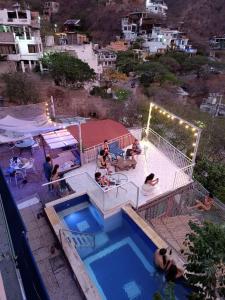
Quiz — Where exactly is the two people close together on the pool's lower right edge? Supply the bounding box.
[154,248,184,282]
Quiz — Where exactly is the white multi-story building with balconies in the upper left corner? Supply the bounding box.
[0,5,43,72]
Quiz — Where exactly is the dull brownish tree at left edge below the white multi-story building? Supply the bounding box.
[2,72,40,105]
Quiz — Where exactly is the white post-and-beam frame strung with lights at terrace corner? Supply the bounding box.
[146,102,202,163]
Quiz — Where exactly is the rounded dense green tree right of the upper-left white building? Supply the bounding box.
[42,52,95,87]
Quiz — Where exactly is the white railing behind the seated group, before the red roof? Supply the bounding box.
[84,133,134,163]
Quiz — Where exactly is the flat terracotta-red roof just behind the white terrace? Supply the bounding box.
[68,119,129,148]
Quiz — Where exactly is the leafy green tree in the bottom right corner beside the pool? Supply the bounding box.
[186,222,225,299]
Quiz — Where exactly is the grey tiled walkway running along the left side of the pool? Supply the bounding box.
[19,203,82,300]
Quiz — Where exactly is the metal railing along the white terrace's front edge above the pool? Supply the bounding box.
[42,172,139,212]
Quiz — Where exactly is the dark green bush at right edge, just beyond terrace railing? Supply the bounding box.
[194,158,225,203]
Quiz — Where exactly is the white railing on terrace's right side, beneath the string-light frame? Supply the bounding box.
[147,128,192,169]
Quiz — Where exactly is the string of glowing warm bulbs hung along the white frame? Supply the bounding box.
[149,102,201,158]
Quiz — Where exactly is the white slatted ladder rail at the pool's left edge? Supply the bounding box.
[59,229,95,248]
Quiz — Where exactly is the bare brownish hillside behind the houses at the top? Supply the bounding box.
[0,0,225,47]
